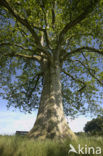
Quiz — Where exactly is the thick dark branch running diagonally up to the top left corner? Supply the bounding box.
[0,0,40,45]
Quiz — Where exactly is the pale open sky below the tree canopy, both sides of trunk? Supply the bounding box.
[0,99,91,135]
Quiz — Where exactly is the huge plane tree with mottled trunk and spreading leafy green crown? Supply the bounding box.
[0,0,103,138]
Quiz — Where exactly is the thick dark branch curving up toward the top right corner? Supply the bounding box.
[58,0,99,47]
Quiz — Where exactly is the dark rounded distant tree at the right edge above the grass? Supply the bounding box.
[84,116,103,135]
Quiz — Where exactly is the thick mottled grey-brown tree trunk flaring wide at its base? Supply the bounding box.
[29,59,75,139]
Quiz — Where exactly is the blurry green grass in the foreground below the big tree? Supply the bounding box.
[0,136,103,156]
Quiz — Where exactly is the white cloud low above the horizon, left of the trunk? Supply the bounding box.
[0,111,36,134]
